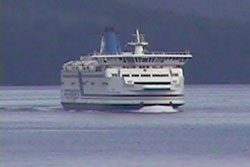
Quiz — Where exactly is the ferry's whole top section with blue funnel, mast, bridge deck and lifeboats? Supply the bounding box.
[64,29,192,71]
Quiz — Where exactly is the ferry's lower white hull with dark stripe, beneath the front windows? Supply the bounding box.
[61,70,184,109]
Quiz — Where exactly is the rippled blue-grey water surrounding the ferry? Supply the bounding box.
[0,85,250,167]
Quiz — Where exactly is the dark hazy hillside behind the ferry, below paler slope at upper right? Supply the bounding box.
[1,0,250,85]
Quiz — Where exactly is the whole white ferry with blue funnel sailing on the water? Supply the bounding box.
[61,27,192,110]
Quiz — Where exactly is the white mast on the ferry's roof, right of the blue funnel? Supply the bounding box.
[128,29,148,54]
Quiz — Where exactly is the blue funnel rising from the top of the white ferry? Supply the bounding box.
[100,27,121,54]
